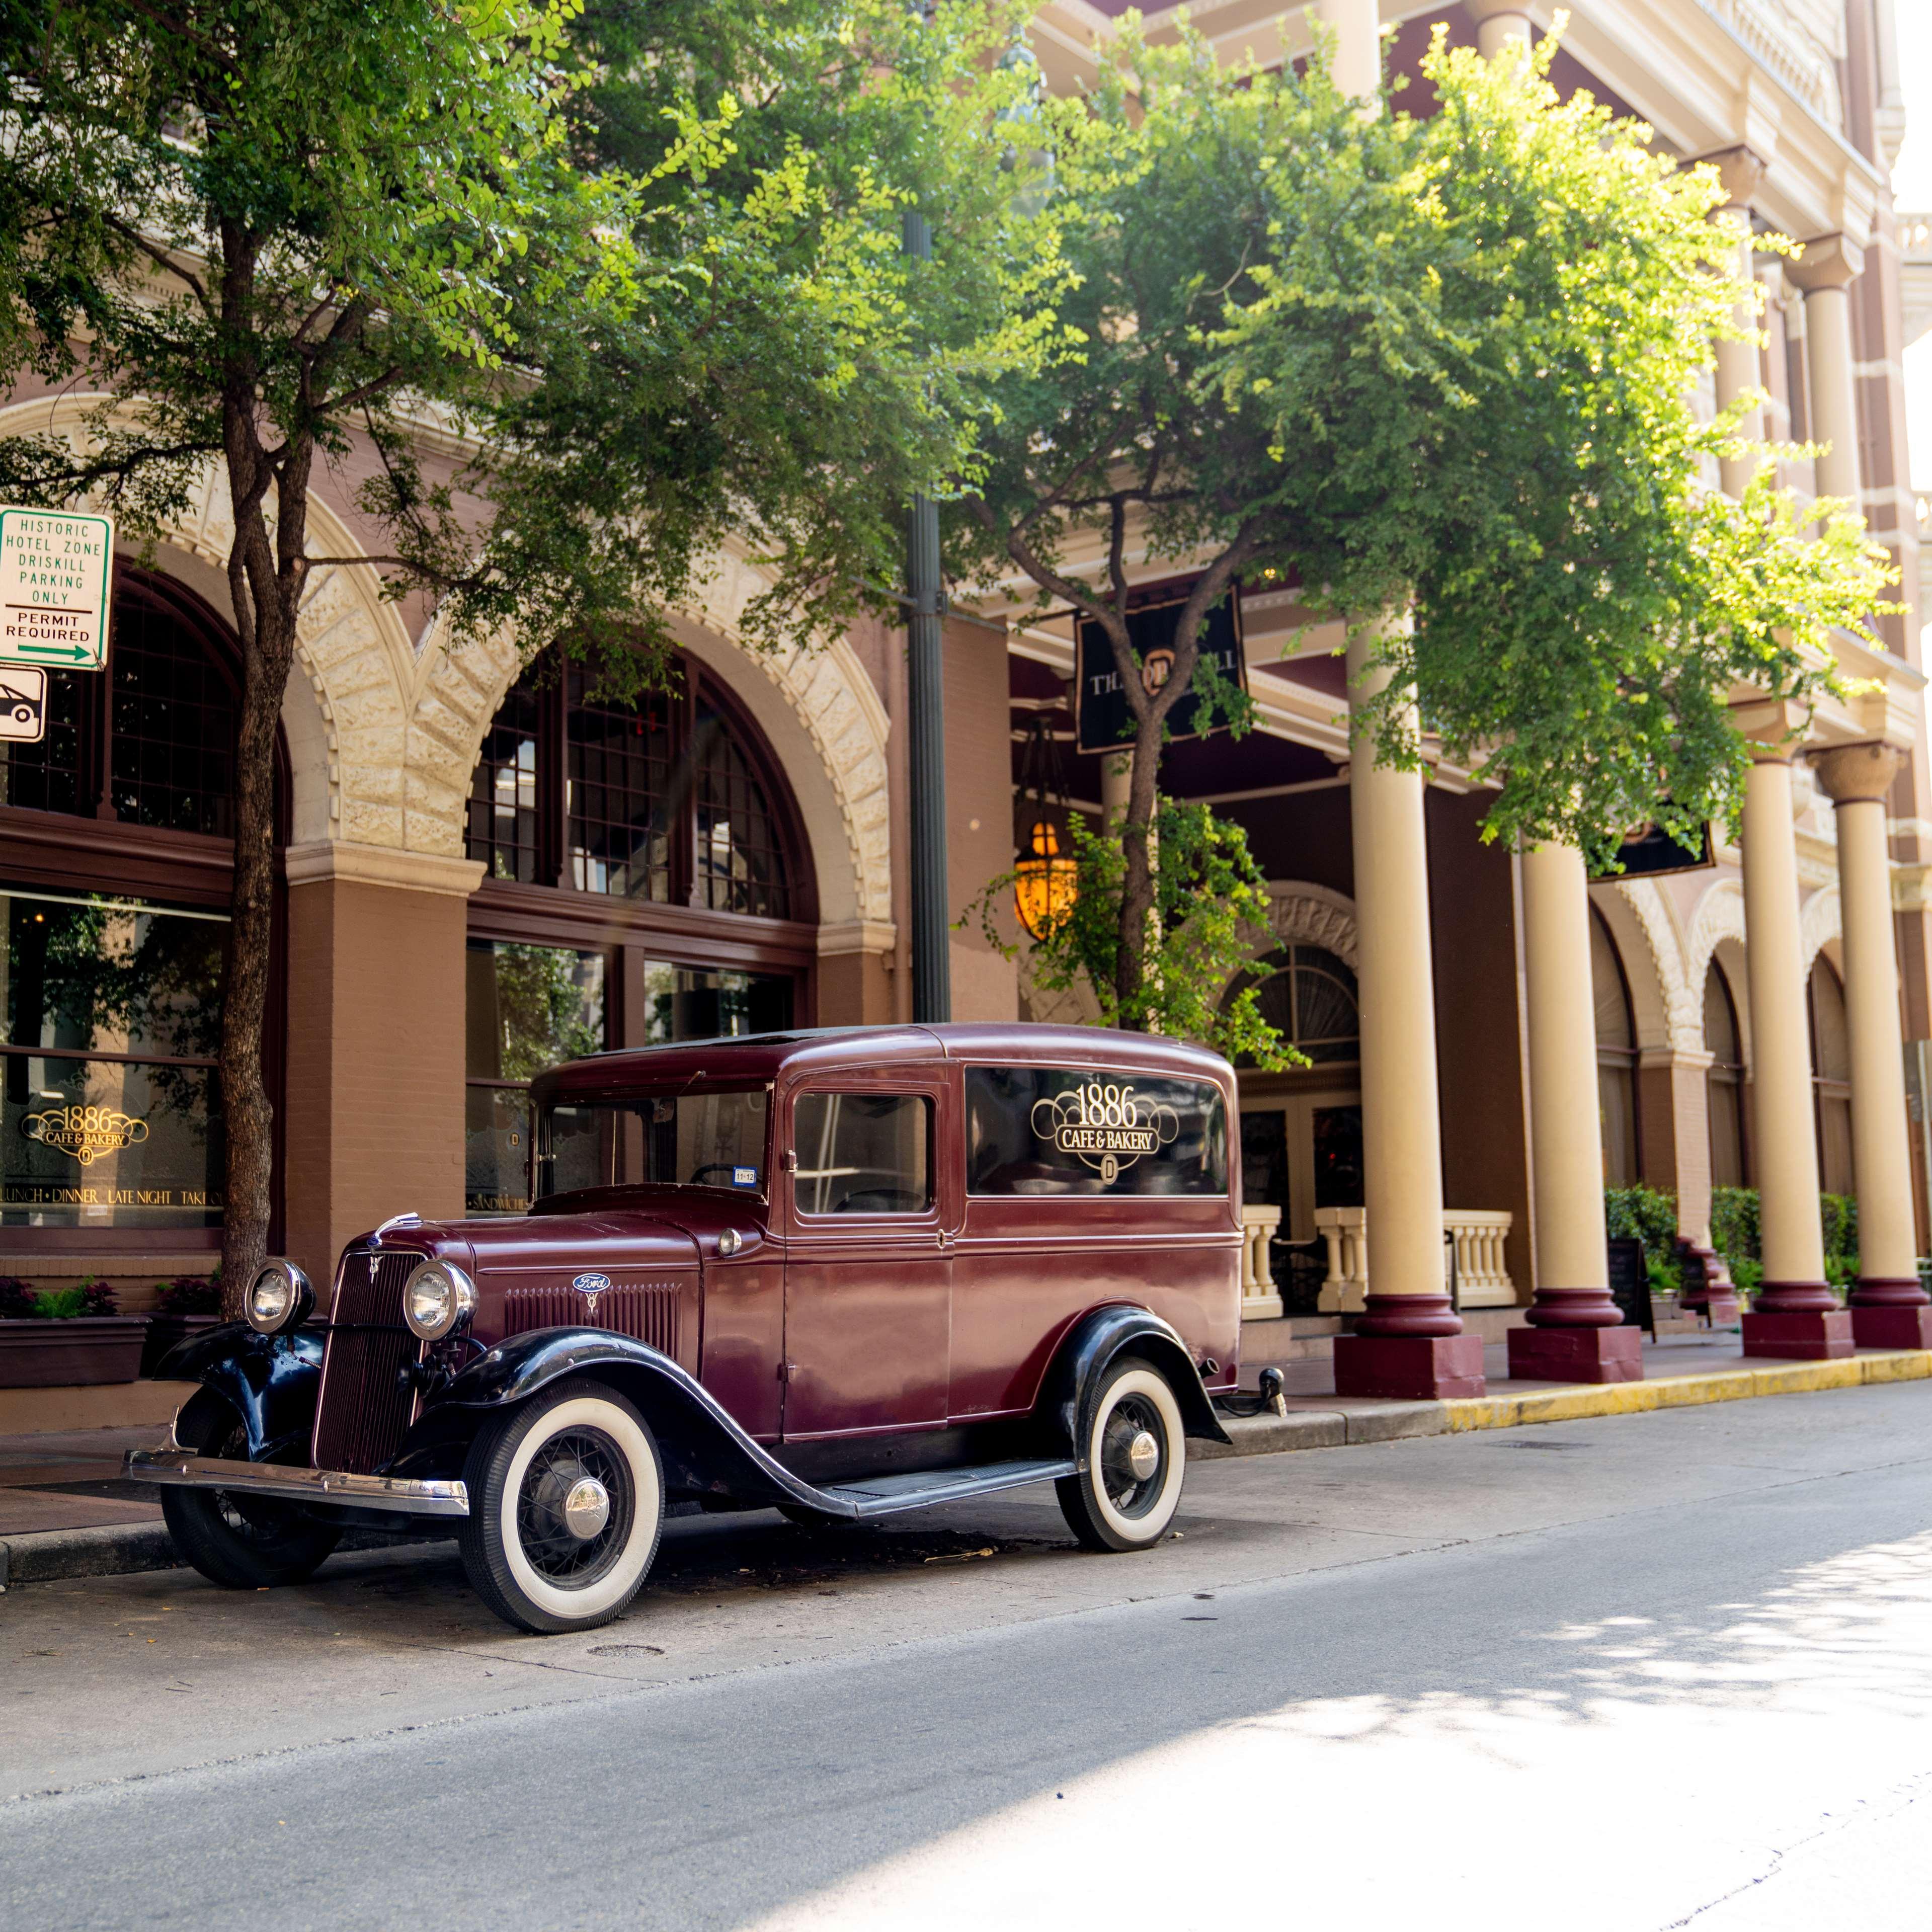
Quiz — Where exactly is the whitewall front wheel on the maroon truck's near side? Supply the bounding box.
[462,1382,665,1636]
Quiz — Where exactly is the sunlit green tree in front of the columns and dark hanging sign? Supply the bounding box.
[950,23,1884,1012]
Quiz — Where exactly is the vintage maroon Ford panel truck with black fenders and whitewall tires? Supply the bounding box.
[127,1026,1240,1633]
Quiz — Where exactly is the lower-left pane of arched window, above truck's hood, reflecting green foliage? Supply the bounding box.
[464,939,605,1215]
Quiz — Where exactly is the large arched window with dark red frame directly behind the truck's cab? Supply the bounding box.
[464,659,817,1214]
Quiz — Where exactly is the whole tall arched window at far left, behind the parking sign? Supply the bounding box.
[0,560,288,1281]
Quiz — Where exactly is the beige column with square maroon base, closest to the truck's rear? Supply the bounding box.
[1335,634,1482,1397]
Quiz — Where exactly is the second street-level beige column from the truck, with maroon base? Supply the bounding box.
[1509,844,1644,1382]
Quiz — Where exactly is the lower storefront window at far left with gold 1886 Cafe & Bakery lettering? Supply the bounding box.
[0,891,228,1229]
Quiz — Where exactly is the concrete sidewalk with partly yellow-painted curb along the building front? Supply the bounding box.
[0,1331,1932,1590]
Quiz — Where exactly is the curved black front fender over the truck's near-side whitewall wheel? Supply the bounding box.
[423,1329,858,1515]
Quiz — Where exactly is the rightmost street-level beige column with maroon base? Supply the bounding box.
[1816,744,1932,1348]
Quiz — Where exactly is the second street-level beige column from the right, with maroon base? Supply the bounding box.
[1745,744,1851,1360]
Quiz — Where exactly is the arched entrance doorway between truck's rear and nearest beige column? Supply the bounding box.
[1229,945,1362,1242]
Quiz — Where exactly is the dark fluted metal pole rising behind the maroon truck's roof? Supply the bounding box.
[900,209,952,1026]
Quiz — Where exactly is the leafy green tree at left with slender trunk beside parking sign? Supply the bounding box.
[0,0,1051,1308]
